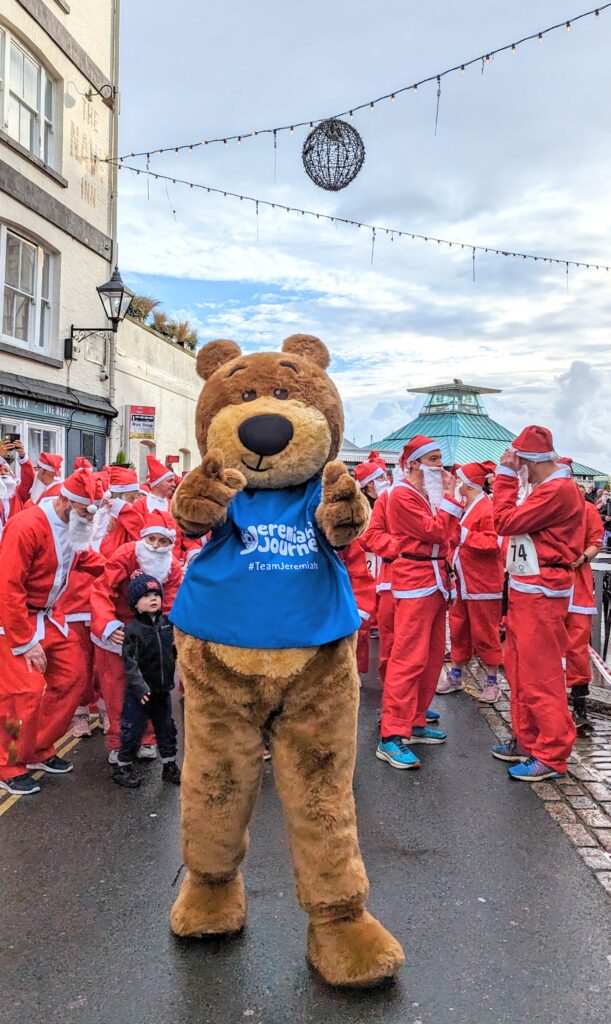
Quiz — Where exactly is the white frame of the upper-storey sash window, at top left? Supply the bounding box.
[0,25,58,170]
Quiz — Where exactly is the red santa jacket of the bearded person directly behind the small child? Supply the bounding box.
[91,541,182,654]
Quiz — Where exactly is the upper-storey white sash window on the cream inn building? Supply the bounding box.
[0,28,56,167]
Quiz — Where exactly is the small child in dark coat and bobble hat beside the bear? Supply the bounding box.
[113,572,180,790]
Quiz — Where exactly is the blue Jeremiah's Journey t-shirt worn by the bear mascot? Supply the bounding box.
[170,478,360,649]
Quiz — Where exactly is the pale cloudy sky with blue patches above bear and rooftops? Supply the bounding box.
[119,0,611,472]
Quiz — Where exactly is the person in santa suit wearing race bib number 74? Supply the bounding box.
[492,426,583,782]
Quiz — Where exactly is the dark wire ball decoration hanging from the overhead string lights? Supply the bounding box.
[302,118,365,191]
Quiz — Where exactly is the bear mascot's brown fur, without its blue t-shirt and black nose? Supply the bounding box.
[171,335,403,985]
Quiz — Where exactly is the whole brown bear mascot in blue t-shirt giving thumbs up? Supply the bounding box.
[171,335,404,986]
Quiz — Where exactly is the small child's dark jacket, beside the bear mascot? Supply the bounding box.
[123,611,176,698]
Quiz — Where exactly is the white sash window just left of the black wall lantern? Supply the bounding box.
[0,224,53,352]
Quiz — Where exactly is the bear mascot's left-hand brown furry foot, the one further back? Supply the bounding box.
[170,871,246,939]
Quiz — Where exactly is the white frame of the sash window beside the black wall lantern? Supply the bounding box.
[0,221,56,355]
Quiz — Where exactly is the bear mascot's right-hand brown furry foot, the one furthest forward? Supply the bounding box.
[307,910,405,988]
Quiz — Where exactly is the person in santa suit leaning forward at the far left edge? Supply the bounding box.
[0,471,103,796]
